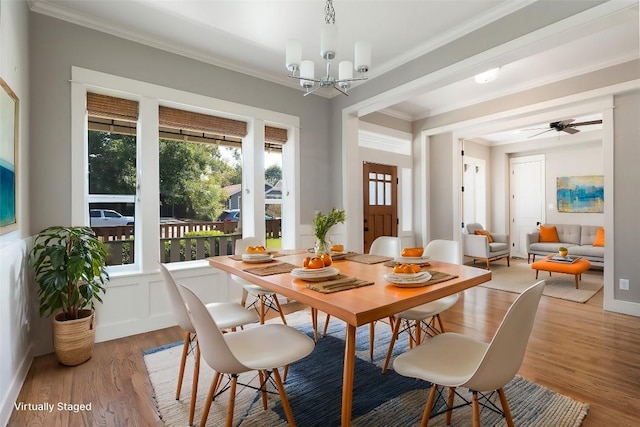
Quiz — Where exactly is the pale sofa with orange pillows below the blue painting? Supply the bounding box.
[527,224,604,267]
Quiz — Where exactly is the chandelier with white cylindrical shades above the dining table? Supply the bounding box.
[286,0,371,96]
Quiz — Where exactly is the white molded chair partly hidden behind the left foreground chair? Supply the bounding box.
[160,264,258,425]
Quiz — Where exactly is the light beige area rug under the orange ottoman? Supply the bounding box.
[480,260,604,303]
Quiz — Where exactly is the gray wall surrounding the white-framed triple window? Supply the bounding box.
[29,13,332,232]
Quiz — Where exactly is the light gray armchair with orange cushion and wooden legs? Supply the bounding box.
[463,223,511,270]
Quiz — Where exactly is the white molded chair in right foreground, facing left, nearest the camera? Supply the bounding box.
[393,281,545,427]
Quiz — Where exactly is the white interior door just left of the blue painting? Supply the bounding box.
[509,155,545,258]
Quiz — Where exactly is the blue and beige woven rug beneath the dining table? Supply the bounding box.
[144,310,588,427]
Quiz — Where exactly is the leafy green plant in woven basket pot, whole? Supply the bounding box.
[29,226,109,366]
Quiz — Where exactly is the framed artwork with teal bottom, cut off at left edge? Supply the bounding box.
[0,78,19,235]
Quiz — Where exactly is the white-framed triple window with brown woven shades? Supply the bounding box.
[71,67,299,277]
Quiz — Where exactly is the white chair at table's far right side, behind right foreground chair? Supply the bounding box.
[382,240,460,373]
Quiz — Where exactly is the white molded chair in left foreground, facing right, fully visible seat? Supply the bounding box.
[181,286,315,427]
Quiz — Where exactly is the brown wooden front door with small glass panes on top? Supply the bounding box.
[362,162,398,252]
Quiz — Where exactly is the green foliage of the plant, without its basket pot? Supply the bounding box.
[29,226,109,320]
